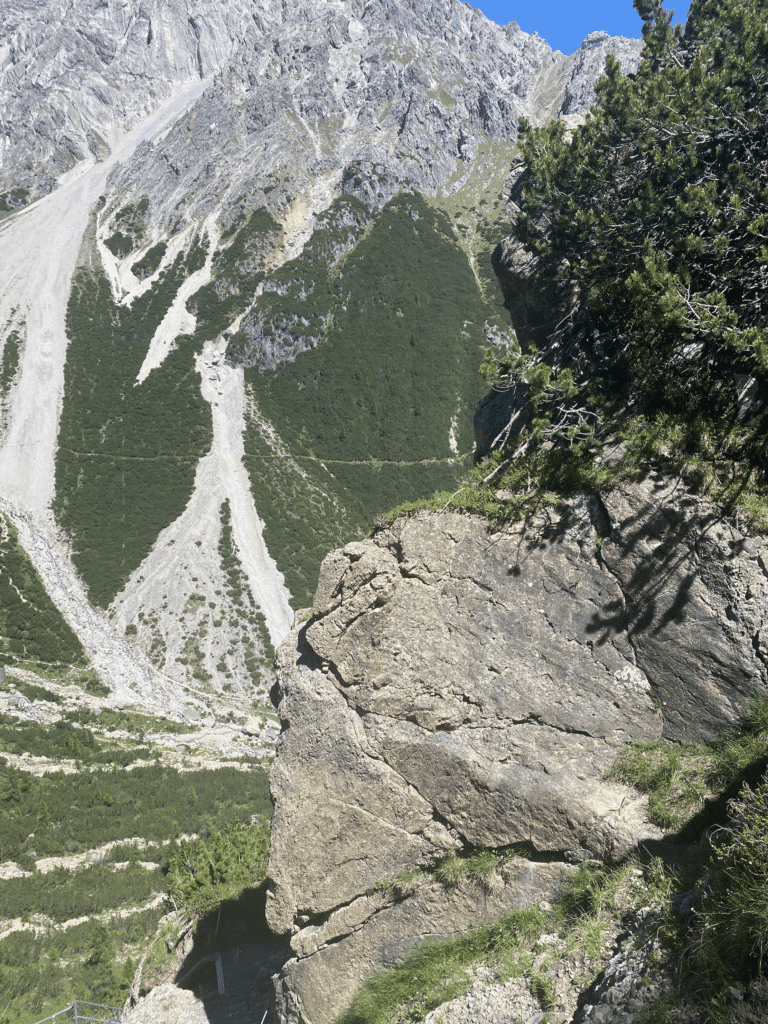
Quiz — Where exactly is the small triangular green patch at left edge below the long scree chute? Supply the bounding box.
[0,515,86,666]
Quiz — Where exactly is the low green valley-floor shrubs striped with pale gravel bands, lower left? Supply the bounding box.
[0,724,271,1024]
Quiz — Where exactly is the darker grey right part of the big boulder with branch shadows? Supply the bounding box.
[595,476,768,740]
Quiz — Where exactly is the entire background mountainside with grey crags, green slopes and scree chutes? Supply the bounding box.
[0,0,639,720]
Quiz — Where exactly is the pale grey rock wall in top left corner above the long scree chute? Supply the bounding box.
[0,0,273,195]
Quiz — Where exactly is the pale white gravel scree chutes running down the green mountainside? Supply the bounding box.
[0,74,293,714]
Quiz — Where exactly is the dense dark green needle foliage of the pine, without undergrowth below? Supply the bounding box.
[507,0,768,460]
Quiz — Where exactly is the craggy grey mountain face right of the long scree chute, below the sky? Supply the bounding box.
[63,0,641,301]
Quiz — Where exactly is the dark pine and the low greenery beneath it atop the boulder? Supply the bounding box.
[473,0,768,524]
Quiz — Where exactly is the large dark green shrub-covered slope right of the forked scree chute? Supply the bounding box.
[240,195,488,606]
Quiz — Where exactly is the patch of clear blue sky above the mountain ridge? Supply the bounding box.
[469,0,690,53]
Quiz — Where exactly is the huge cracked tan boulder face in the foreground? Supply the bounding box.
[267,476,768,1024]
